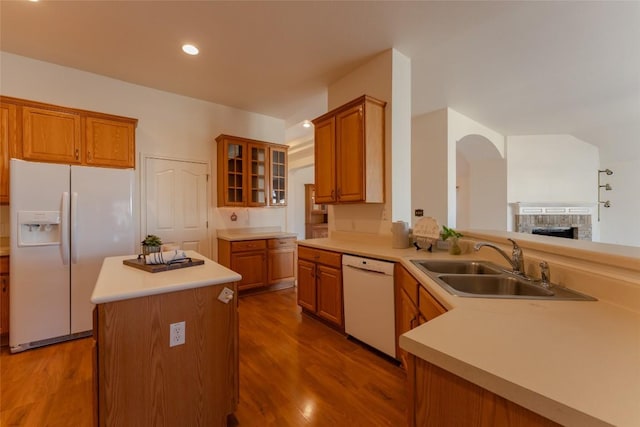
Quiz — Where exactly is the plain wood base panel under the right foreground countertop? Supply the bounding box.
[407,354,560,427]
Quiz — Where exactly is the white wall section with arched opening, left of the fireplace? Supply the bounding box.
[412,108,506,229]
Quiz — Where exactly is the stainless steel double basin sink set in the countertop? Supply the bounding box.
[411,260,596,301]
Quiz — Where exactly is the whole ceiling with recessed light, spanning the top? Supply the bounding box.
[0,0,640,157]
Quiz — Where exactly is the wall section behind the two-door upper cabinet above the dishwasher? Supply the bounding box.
[328,49,411,235]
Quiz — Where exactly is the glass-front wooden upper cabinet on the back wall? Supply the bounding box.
[216,135,288,207]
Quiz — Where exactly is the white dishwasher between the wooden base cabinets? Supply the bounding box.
[342,255,396,358]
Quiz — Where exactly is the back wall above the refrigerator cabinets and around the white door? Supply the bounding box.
[0,52,285,260]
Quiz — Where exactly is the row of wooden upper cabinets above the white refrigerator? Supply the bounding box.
[0,96,138,171]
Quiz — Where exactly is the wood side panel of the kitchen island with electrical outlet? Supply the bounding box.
[94,284,238,426]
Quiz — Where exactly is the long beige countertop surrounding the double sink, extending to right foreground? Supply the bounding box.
[299,237,640,426]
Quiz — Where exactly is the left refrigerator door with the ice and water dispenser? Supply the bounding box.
[9,159,70,351]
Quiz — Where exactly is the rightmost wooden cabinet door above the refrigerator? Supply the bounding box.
[85,117,135,168]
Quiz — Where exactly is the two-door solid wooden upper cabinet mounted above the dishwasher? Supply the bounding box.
[313,95,386,204]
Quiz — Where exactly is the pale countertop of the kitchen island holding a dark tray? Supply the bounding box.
[91,251,242,304]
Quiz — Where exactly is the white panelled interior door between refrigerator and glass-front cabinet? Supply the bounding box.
[145,157,211,257]
